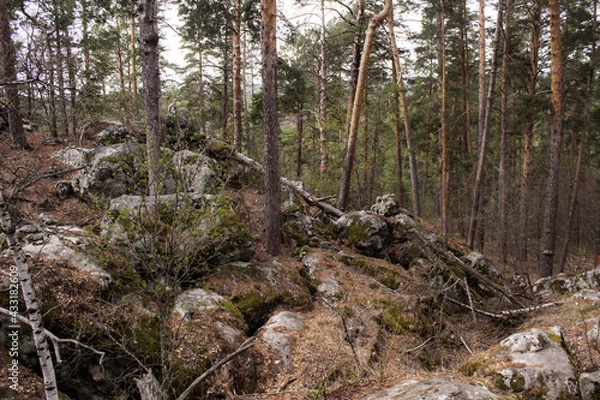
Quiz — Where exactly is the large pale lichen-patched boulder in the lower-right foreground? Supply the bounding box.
[463,328,579,400]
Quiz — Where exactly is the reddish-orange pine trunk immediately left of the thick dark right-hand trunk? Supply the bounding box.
[518,0,542,262]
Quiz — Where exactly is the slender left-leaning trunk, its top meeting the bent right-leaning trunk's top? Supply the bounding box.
[388,11,421,217]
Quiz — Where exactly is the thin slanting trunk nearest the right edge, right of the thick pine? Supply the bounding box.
[557,0,598,274]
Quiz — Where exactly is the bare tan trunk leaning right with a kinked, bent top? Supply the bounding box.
[338,0,392,210]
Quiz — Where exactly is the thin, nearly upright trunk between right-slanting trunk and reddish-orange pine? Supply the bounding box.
[498,0,512,264]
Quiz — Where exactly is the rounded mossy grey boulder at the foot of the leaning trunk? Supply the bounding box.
[335,211,391,258]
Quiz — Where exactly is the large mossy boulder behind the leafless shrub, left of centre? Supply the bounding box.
[101,194,254,279]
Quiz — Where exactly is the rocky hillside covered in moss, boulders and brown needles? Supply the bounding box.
[0,126,600,400]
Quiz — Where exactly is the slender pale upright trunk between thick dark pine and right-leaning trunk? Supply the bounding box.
[319,0,330,179]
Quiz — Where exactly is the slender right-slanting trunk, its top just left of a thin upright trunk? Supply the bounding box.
[467,0,503,248]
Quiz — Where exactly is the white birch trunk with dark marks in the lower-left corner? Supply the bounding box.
[0,191,58,400]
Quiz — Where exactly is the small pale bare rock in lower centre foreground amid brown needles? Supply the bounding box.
[262,311,306,373]
